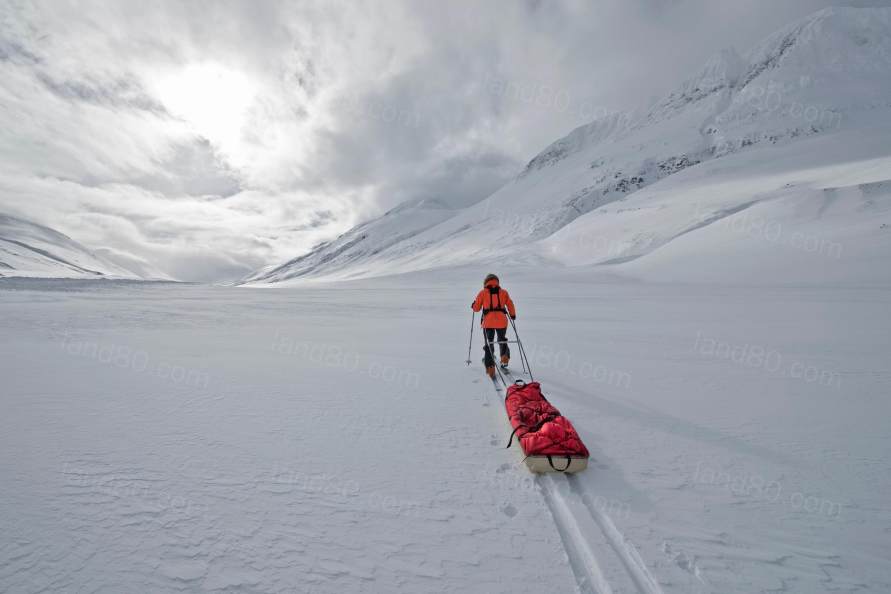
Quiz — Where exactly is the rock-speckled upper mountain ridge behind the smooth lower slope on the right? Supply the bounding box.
[244,8,891,283]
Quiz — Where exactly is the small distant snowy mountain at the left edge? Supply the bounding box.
[0,215,141,279]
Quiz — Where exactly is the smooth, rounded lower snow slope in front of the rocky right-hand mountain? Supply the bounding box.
[541,120,891,285]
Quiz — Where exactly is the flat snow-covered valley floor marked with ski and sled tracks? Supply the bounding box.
[0,266,891,594]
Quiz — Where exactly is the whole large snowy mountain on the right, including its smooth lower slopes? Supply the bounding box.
[244,8,891,283]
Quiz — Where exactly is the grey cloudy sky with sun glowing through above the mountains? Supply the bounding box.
[0,0,888,281]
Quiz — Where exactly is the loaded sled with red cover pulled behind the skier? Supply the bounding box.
[504,380,588,473]
